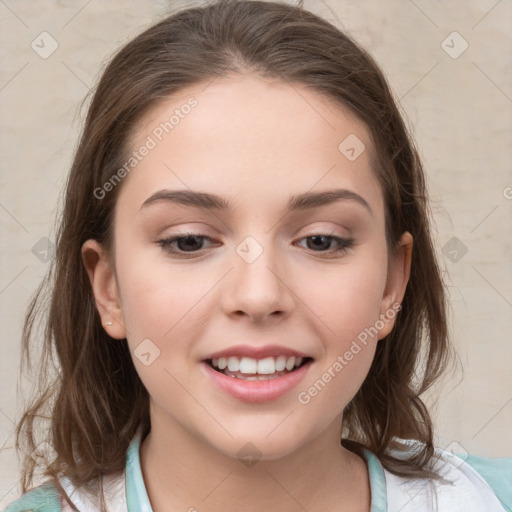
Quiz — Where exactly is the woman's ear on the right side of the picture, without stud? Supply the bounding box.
[378,231,413,340]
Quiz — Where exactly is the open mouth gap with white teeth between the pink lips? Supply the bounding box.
[204,355,313,381]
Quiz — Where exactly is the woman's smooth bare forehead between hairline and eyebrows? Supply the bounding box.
[120,76,382,218]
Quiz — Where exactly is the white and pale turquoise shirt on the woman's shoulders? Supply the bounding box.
[4,429,512,512]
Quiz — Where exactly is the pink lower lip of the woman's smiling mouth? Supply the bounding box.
[201,360,312,403]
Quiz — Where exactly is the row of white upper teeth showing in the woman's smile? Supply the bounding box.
[212,356,304,374]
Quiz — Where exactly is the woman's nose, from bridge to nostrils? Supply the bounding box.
[221,237,295,322]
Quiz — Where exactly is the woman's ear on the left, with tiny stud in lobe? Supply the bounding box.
[82,239,126,339]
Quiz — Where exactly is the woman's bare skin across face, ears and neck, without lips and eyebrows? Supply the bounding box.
[82,75,412,512]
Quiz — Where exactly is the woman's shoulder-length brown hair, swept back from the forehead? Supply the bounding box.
[16,0,451,506]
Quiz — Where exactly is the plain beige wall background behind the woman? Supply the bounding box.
[0,0,512,506]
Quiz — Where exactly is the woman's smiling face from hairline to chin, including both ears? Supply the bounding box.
[84,76,411,459]
